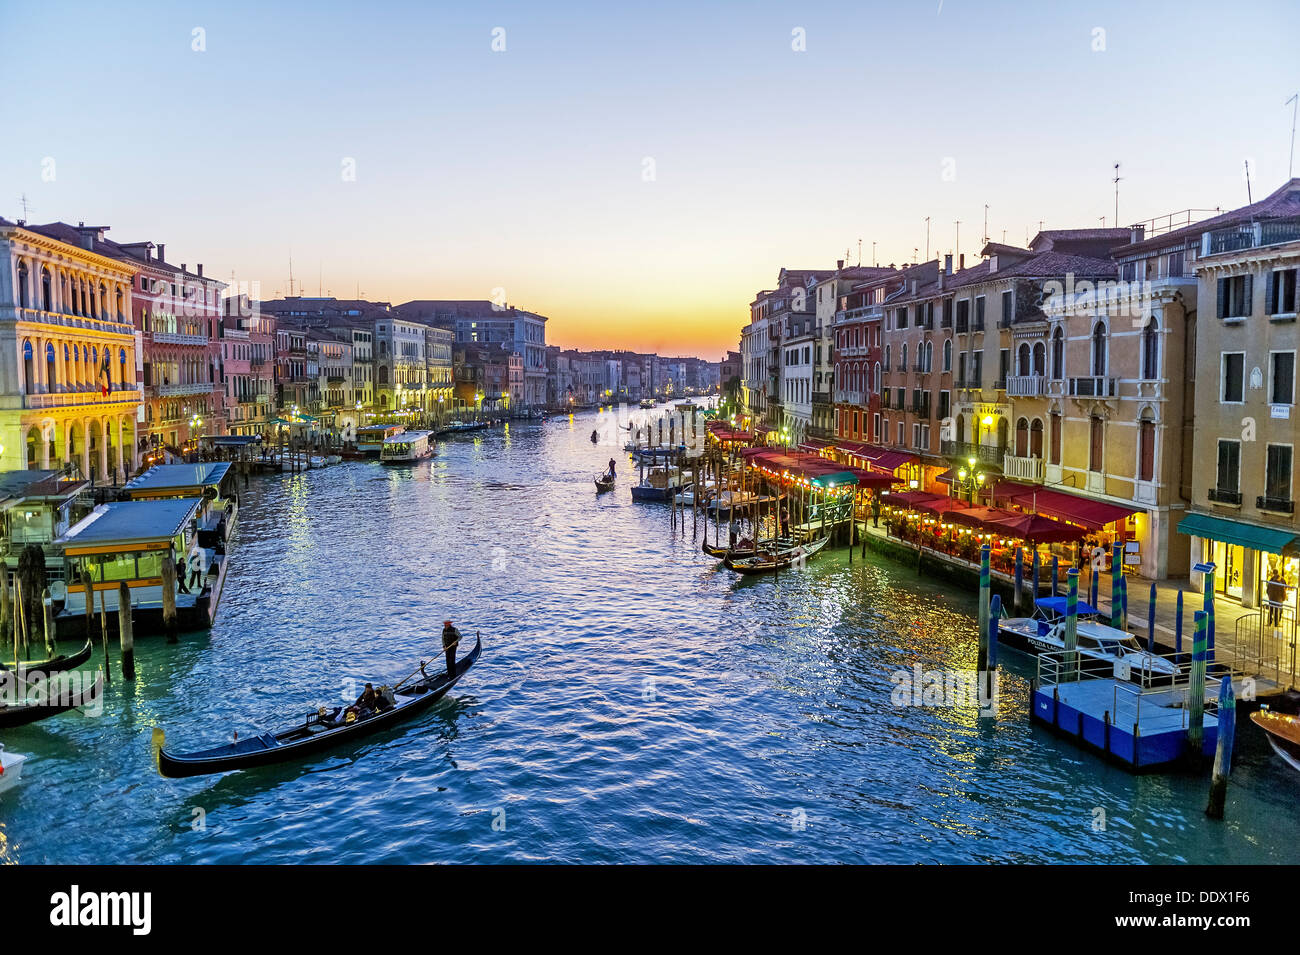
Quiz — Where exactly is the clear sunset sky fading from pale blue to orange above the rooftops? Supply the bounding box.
[0,0,1300,359]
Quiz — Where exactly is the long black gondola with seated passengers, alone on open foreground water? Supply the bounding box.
[153,637,484,778]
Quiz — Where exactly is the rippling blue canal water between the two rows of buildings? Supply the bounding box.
[0,413,1300,863]
